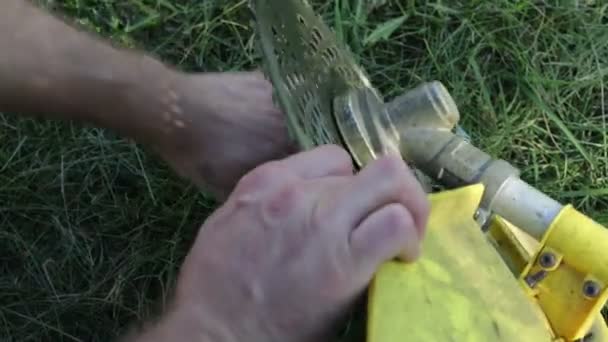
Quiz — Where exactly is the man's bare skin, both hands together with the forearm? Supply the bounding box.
[0,0,429,342]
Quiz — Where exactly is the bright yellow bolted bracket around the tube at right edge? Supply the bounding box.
[520,206,608,341]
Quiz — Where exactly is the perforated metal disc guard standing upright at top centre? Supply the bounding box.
[250,0,378,149]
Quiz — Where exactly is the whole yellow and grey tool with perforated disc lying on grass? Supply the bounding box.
[251,0,608,342]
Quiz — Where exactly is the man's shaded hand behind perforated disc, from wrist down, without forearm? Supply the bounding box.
[156,72,295,198]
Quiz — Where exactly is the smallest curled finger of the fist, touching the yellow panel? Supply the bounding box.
[350,204,420,272]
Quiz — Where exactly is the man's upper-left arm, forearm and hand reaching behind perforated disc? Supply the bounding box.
[0,0,291,197]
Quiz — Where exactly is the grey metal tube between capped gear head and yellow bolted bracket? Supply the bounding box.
[401,125,563,240]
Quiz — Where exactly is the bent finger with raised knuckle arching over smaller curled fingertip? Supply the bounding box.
[336,157,429,236]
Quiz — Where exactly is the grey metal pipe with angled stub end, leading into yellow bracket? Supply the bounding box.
[386,82,563,240]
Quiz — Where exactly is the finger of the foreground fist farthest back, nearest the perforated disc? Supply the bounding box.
[279,145,353,179]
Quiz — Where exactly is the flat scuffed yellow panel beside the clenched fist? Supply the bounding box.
[368,185,553,342]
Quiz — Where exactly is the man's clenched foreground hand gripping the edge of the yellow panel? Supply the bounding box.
[134,146,429,342]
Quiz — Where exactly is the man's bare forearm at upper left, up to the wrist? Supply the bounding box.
[0,0,178,144]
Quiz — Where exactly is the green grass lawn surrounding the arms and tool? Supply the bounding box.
[0,0,608,341]
